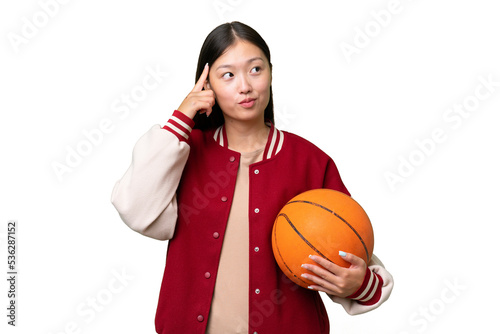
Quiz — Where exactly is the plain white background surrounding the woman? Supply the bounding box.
[0,0,500,334]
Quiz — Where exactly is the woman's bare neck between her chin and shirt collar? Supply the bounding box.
[224,120,269,152]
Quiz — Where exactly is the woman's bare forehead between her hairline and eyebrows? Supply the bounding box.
[212,40,266,69]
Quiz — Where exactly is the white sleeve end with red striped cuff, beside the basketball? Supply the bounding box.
[328,254,394,315]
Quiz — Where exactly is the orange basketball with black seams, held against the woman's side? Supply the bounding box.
[272,189,374,288]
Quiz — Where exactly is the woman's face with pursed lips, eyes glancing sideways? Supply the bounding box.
[206,40,271,122]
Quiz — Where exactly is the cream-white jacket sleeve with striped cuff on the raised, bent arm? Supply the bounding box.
[111,111,193,240]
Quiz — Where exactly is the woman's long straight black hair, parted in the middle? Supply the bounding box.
[193,21,274,130]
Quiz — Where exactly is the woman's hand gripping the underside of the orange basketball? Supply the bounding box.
[302,253,366,297]
